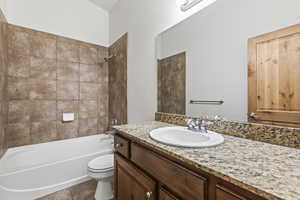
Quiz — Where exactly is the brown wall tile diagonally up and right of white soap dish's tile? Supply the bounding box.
[80,83,99,100]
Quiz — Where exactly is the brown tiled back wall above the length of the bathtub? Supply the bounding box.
[1,24,109,148]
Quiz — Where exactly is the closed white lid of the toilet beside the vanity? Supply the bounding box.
[88,154,114,170]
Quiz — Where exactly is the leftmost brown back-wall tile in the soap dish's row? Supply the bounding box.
[8,100,32,123]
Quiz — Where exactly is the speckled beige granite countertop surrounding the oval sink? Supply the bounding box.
[114,122,300,200]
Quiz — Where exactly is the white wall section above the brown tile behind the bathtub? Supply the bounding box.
[4,0,109,46]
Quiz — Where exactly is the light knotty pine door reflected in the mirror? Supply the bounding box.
[248,25,300,127]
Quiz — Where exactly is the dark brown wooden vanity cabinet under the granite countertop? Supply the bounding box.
[115,134,266,200]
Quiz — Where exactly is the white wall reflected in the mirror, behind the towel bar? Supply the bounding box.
[160,0,300,121]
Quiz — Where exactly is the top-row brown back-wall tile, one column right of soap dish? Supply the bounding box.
[79,45,99,64]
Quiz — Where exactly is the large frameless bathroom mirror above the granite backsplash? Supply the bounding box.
[156,1,300,126]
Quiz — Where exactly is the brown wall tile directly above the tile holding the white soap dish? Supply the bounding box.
[57,81,79,100]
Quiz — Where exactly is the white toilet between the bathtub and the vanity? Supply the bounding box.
[88,154,114,200]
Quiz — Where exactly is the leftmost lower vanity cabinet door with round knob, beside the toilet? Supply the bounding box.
[115,155,156,200]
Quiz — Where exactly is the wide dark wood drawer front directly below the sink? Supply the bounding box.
[131,143,207,200]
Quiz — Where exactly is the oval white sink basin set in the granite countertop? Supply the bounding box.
[150,126,224,148]
